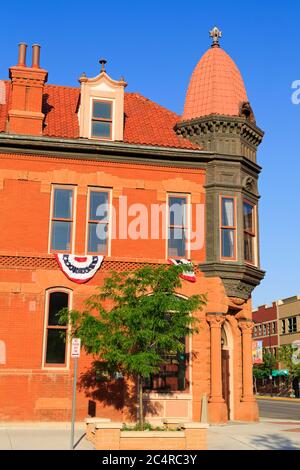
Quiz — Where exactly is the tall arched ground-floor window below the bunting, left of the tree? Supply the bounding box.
[44,291,69,366]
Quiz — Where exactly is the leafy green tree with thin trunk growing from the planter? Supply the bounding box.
[60,265,206,429]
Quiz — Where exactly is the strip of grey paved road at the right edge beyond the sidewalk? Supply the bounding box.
[257,400,300,422]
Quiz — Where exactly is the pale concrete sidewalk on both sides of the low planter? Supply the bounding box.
[0,416,300,450]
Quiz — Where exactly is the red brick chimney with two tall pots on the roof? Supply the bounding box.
[7,43,48,135]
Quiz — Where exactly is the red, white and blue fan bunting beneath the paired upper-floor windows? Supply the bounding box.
[55,254,104,284]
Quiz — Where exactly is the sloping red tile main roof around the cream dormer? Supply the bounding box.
[0,81,200,150]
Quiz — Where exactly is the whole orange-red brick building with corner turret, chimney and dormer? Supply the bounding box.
[0,28,264,422]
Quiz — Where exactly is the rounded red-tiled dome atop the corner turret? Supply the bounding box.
[182,47,248,121]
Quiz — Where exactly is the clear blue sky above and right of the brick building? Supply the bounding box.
[0,0,300,305]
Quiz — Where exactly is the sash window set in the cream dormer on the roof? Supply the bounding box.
[91,100,113,140]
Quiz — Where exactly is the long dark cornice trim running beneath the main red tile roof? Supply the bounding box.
[0,133,261,173]
